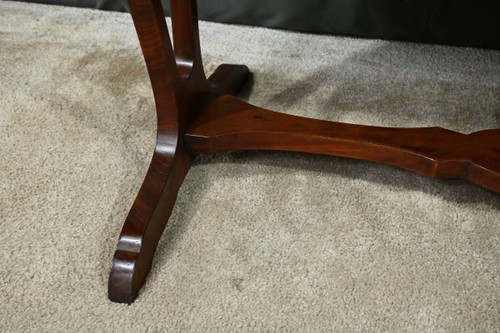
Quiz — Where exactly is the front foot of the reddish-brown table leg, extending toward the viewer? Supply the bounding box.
[108,147,192,303]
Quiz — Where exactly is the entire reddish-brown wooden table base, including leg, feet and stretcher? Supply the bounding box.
[108,0,500,303]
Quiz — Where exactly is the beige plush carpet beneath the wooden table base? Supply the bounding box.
[0,1,500,332]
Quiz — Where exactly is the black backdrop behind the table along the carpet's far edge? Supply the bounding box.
[13,0,500,49]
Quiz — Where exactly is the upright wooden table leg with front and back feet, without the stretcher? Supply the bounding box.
[108,0,248,303]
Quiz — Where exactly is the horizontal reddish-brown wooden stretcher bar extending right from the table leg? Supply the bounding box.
[184,95,500,192]
